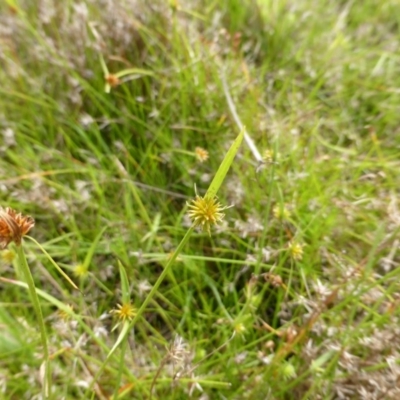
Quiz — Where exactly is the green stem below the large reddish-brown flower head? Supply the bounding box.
[16,245,51,399]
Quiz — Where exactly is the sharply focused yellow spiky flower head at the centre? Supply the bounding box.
[186,195,228,236]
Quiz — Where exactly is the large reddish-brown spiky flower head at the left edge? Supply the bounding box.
[0,207,35,250]
